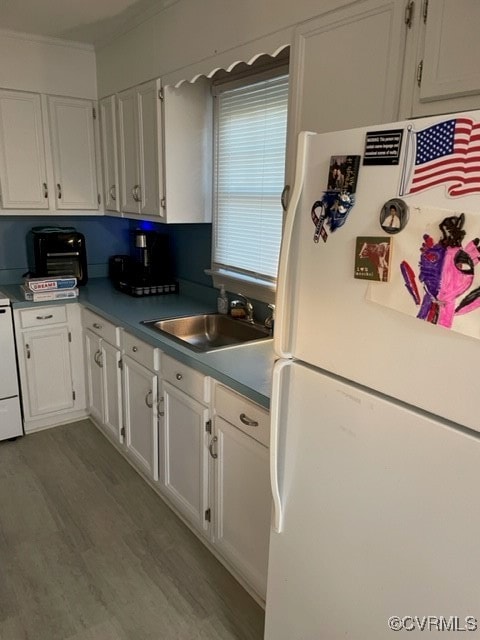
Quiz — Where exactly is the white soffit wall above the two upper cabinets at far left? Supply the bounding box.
[0,31,97,99]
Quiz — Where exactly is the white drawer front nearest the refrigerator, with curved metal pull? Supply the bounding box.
[215,385,270,447]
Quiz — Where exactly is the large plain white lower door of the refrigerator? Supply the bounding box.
[265,362,480,640]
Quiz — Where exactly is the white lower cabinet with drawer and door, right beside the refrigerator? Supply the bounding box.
[212,385,272,598]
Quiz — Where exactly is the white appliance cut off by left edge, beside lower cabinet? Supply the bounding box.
[0,292,23,440]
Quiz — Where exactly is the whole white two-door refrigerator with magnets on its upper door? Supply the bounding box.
[265,112,480,640]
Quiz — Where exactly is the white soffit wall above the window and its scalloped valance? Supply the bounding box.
[97,0,348,97]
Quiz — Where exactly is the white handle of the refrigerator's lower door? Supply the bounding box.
[270,360,292,533]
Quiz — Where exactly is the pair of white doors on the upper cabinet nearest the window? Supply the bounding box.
[118,80,163,216]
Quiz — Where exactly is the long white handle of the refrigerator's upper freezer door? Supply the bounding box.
[273,131,315,358]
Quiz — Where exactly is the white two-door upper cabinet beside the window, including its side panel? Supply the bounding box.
[113,78,213,223]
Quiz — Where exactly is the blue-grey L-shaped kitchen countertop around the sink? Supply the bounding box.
[1,278,274,408]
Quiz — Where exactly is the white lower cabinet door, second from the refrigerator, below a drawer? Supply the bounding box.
[160,382,209,531]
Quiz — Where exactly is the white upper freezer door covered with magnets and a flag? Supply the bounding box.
[274,112,480,430]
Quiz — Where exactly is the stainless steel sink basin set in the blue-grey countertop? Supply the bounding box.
[142,313,271,351]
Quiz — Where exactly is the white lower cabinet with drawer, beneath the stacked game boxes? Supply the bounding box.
[14,305,86,433]
